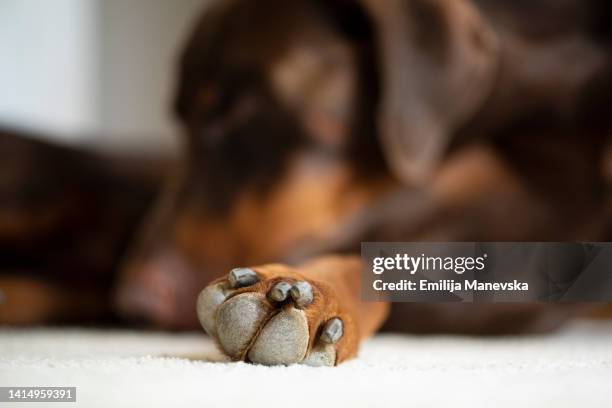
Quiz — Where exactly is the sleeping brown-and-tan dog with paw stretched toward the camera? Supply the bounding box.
[0,0,612,365]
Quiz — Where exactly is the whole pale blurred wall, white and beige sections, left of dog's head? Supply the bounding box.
[0,0,208,150]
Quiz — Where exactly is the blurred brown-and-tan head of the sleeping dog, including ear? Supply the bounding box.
[119,0,500,325]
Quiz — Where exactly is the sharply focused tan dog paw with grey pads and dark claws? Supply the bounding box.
[197,265,354,366]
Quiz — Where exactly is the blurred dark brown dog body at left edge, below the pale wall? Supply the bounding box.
[0,128,167,324]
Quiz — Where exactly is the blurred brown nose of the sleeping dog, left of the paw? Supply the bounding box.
[115,252,203,329]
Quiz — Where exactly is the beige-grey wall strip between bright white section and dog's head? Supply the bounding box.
[99,0,203,147]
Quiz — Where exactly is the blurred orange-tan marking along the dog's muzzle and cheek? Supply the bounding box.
[172,151,390,271]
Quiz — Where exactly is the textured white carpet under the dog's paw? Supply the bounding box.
[0,322,612,408]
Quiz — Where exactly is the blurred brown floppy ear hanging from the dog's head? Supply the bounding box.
[360,0,498,184]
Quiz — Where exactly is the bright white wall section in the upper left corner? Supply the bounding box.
[0,0,99,138]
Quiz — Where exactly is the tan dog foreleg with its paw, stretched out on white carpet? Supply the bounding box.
[197,256,388,366]
